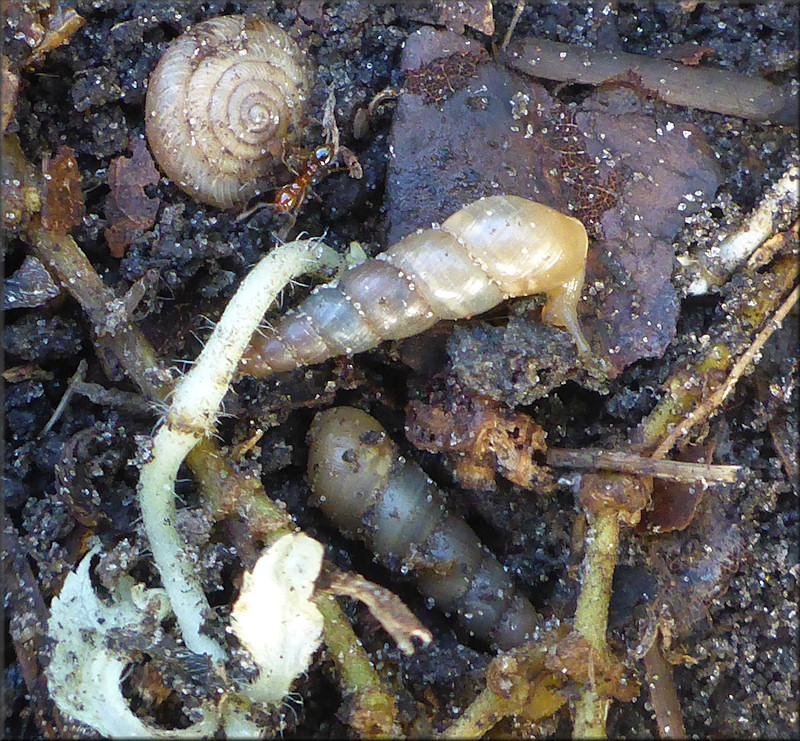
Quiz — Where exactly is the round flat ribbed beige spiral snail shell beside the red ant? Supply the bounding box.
[145,15,309,208]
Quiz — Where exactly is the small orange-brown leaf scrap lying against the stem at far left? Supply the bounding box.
[42,147,86,235]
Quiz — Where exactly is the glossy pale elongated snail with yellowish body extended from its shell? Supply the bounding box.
[240,196,589,377]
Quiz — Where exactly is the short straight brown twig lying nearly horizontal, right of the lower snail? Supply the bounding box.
[547,448,742,484]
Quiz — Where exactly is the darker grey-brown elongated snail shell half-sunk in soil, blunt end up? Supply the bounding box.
[308,407,539,649]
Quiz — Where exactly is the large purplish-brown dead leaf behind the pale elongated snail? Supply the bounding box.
[385,28,718,382]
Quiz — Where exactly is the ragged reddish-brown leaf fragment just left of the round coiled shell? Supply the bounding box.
[104,139,161,258]
